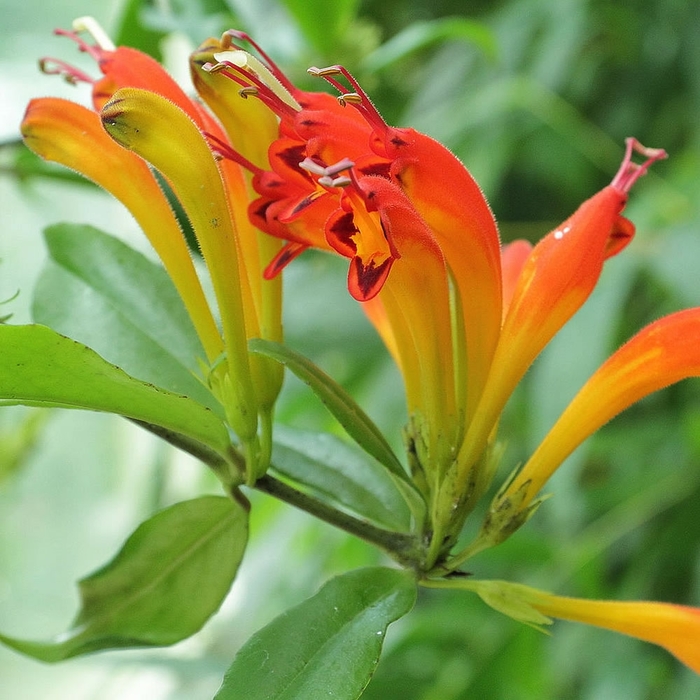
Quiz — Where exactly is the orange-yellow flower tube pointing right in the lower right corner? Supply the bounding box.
[529,590,700,673]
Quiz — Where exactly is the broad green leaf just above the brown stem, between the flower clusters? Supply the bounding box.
[272,426,410,532]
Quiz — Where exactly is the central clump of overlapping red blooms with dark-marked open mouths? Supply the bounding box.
[193,46,502,558]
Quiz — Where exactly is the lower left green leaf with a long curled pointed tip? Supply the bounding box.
[0,496,248,662]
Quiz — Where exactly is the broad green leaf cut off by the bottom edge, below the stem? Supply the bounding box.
[215,567,416,700]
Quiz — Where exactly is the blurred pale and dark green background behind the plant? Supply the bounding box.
[0,0,700,700]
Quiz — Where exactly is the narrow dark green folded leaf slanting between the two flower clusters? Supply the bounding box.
[248,338,410,483]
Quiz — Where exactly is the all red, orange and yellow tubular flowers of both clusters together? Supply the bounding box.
[23,16,700,672]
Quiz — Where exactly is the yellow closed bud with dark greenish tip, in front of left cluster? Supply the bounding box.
[101,88,257,442]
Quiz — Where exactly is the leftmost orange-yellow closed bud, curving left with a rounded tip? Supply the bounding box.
[22,97,223,362]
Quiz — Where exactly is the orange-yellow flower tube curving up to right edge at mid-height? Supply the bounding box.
[503,308,700,507]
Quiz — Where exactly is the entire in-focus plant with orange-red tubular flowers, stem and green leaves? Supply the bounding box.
[0,13,700,700]
